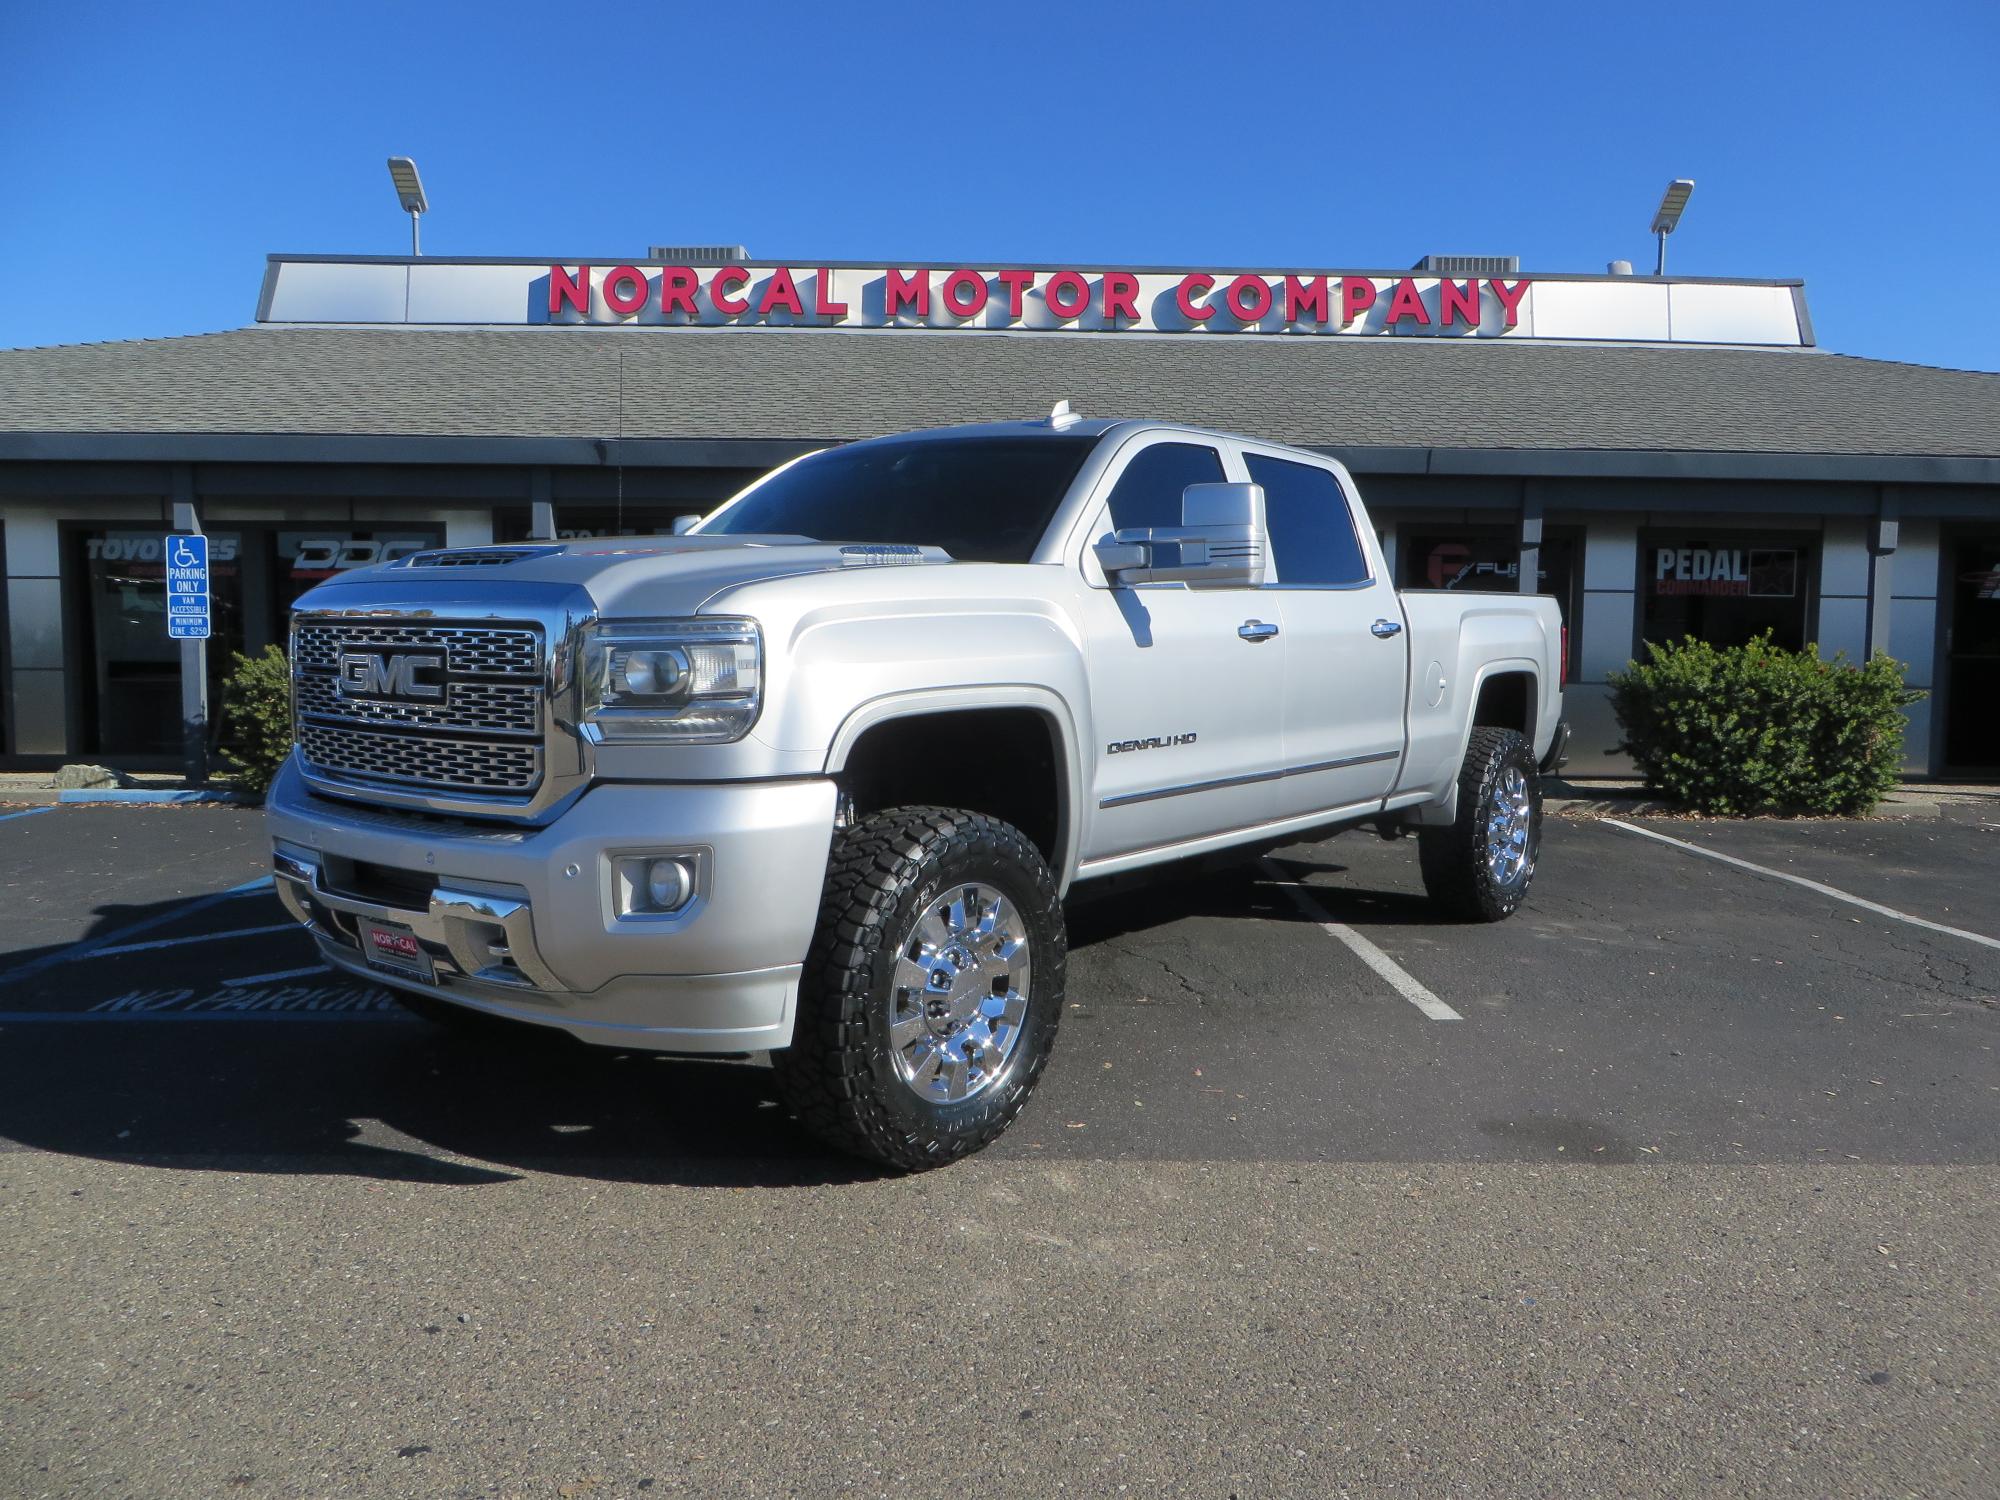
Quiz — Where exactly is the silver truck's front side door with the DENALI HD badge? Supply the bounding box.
[1078,432,1284,862]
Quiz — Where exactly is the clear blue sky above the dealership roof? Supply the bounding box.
[0,0,2000,370]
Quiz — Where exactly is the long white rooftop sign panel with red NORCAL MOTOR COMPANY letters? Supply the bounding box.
[258,256,1812,346]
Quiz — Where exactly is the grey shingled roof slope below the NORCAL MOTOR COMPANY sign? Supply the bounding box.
[0,328,2000,458]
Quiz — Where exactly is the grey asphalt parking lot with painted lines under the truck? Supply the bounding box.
[0,808,2000,1496]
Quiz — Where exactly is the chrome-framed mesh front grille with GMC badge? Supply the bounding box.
[292,620,548,798]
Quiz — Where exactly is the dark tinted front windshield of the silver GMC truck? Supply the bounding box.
[700,436,1096,562]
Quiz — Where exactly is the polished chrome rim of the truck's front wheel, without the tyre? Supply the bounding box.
[888,884,1032,1104]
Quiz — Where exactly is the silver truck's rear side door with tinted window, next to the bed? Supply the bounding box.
[1242,444,1410,816]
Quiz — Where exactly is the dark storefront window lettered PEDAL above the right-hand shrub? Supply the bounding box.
[1640,532,1814,650]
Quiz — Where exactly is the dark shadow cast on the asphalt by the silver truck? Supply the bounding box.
[0,854,1430,1186]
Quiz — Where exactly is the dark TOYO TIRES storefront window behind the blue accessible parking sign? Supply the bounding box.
[72,526,244,756]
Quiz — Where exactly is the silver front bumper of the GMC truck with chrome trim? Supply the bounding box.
[266,766,834,1054]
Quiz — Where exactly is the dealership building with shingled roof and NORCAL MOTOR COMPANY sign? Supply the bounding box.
[0,248,2000,778]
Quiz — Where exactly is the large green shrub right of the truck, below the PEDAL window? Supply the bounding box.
[1610,630,1924,816]
